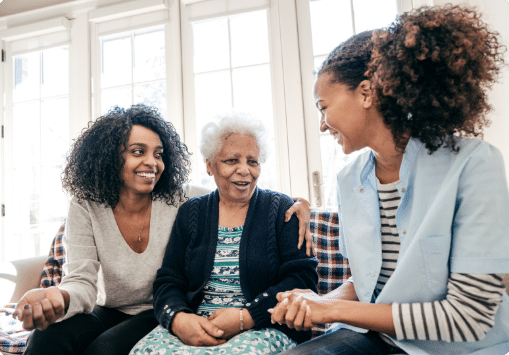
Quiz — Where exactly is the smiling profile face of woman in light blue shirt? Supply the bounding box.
[313,73,371,154]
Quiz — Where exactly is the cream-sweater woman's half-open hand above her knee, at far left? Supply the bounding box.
[12,287,68,330]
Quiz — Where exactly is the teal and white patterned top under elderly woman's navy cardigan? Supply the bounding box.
[196,226,246,317]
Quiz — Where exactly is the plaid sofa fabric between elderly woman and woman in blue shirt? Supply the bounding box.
[309,210,351,337]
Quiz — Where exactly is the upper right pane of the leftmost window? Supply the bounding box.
[41,46,69,97]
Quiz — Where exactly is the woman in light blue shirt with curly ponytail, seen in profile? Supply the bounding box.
[269,5,509,355]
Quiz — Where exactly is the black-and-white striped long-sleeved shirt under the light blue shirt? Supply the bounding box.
[376,181,505,342]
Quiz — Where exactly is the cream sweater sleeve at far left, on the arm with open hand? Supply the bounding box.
[58,198,100,321]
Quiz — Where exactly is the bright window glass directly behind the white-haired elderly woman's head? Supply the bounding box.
[187,10,277,189]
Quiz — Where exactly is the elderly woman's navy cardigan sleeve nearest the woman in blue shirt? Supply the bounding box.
[246,195,318,329]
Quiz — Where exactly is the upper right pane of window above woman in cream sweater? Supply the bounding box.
[134,26,166,83]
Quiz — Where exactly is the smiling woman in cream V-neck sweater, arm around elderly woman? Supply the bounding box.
[14,105,309,355]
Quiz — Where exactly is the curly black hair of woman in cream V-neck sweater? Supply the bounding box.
[62,105,191,208]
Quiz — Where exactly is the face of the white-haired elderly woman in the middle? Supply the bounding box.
[207,133,260,203]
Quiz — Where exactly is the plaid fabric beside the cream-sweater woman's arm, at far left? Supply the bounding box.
[41,219,65,288]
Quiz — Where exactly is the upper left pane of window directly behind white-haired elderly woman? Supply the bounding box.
[193,18,230,73]
